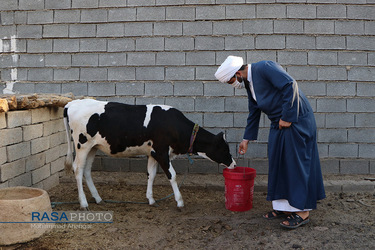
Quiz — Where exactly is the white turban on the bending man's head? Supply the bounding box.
[215,56,243,83]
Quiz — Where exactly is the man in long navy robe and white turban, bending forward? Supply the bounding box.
[215,56,325,228]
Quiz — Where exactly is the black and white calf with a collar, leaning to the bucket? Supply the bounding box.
[64,99,236,209]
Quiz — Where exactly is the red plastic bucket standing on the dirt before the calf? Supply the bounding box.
[223,167,256,212]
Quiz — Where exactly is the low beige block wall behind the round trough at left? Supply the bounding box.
[0,107,67,190]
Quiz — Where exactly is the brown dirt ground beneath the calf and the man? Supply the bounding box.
[0,173,375,249]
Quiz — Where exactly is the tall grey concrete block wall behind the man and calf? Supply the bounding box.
[0,0,375,174]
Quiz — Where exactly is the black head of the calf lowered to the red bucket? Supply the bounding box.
[198,132,236,168]
